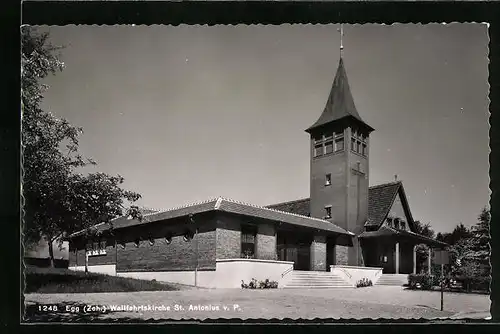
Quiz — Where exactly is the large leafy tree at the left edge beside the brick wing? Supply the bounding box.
[21,26,140,266]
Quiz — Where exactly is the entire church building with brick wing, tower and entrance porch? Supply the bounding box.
[69,58,446,287]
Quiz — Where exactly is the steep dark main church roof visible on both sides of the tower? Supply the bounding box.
[267,181,404,226]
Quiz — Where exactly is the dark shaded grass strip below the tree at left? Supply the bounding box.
[24,267,179,293]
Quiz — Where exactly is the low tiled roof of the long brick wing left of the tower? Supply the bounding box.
[70,197,352,238]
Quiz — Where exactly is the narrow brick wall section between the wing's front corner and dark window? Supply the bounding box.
[215,214,241,259]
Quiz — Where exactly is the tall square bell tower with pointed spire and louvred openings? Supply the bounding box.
[306,34,374,266]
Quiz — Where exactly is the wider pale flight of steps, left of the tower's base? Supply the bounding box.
[283,270,353,289]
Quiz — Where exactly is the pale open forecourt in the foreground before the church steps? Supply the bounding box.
[25,286,490,321]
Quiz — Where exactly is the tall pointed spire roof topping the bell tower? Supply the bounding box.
[306,58,373,132]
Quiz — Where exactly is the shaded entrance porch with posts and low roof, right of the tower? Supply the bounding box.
[359,226,448,274]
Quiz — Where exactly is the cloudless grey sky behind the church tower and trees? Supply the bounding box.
[37,23,490,243]
